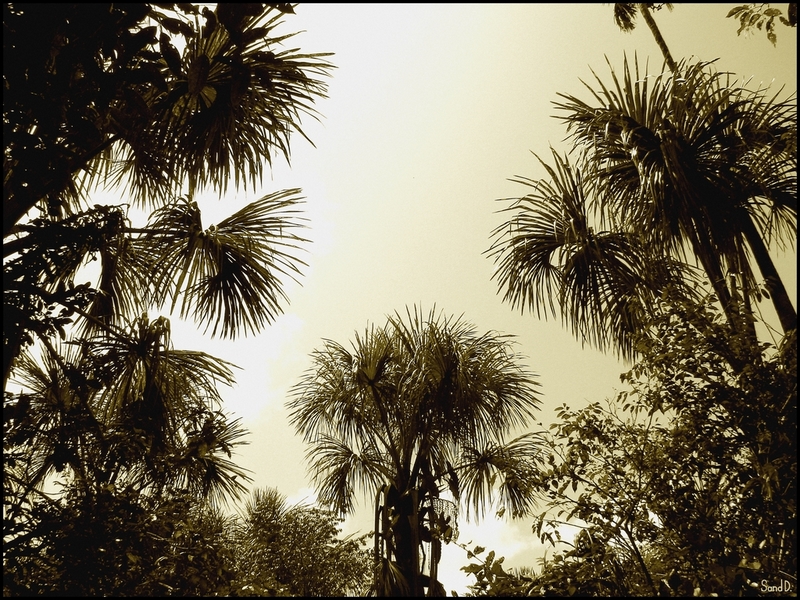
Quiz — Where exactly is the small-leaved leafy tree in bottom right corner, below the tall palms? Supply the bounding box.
[533,302,797,595]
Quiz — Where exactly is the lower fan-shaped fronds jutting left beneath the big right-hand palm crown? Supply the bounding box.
[489,151,691,358]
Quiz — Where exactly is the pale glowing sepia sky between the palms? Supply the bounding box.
[79,4,797,594]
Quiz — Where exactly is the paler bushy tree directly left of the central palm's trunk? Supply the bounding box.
[230,488,374,597]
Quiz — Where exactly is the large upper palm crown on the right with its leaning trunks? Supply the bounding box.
[556,56,797,333]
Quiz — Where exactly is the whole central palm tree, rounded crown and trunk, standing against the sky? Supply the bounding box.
[288,308,539,595]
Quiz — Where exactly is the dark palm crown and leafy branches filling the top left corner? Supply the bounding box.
[3,3,333,234]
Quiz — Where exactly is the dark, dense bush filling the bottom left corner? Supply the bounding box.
[3,487,234,597]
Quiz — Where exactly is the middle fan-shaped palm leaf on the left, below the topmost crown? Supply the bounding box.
[145,189,307,337]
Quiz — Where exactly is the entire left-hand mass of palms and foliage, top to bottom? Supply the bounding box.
[3,3,332,595]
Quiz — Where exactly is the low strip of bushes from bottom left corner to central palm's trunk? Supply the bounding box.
[3,488,373,597]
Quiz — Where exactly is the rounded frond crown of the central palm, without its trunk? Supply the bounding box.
[287,307,540,515]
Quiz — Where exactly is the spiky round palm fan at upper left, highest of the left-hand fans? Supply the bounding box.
[97,6,333,203]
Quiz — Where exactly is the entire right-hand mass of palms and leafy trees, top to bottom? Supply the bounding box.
[464,3,797,596]
